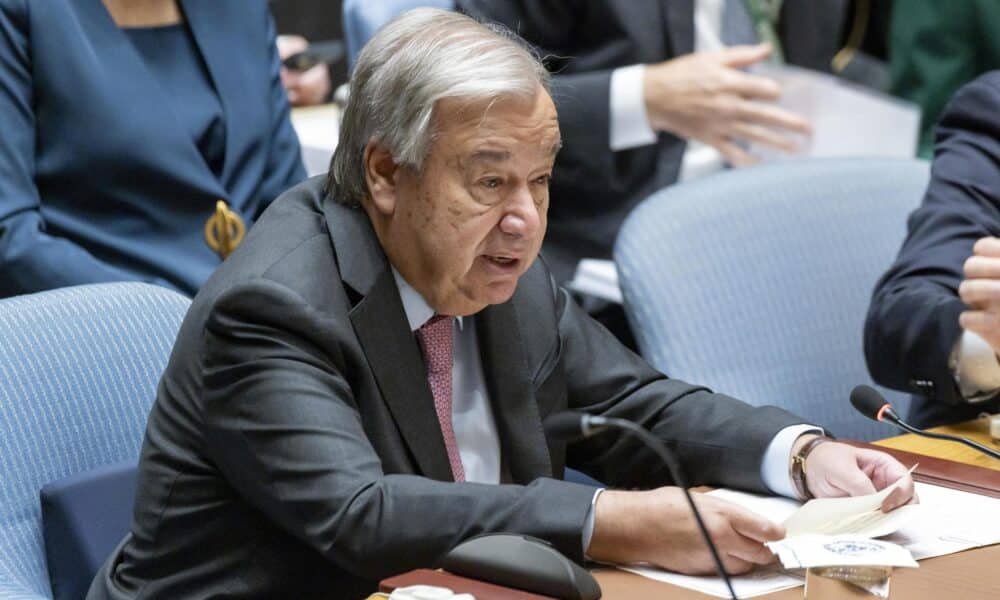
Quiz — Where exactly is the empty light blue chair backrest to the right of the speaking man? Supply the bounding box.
[615,159,929,440]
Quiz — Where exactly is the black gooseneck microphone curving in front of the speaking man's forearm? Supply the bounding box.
[542,411,739,600]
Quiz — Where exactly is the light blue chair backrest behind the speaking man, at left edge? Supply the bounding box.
[0,283,190,599]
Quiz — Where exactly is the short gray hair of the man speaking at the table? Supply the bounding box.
[327,8,549,204]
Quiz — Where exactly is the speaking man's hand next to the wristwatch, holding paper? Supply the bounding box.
[792,435,916,512]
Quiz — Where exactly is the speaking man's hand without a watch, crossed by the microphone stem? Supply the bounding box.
[587,487,785,575]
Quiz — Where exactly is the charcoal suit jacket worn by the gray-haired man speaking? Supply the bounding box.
[89,178,800,599]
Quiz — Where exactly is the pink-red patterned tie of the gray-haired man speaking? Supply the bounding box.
[417,315,465,481]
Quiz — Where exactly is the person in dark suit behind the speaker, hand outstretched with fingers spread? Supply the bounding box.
[457,0,844,282]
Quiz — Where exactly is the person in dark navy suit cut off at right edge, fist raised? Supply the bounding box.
[865,71,1000,427]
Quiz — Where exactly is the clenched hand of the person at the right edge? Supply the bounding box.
[958,237,1000,354]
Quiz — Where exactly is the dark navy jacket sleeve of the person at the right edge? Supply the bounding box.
[865,71,1000,426]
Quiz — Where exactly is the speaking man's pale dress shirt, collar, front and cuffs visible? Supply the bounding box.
[392,268,819,551]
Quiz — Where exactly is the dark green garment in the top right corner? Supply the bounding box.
[889,0,1000,157]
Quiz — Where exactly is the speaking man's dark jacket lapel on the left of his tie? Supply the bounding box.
[324,199,453,481]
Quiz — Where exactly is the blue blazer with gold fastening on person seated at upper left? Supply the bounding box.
[0,0,305,297]
